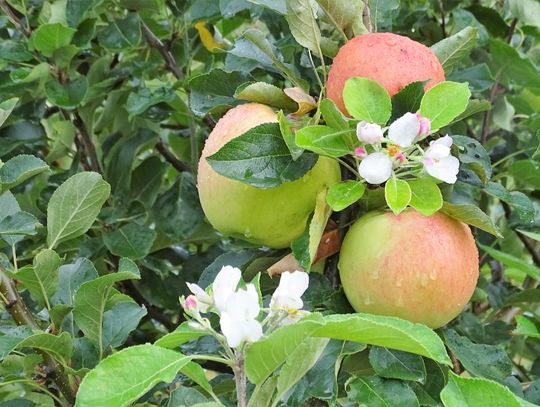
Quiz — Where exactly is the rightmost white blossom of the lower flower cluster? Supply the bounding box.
[270,270,309,312]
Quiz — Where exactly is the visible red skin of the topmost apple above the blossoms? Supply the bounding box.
[326,33,444,114]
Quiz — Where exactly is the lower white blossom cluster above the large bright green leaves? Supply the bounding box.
[181,266,309,348]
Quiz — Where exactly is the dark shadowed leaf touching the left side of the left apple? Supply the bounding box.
[152,172,204,241]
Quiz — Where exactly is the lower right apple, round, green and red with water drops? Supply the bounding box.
[339,210,478,328]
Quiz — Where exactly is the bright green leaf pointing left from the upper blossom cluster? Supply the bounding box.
[296,125,354,157]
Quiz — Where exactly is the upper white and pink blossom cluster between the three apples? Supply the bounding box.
[354,112,459,184]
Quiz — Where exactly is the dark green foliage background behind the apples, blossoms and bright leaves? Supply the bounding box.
[0,0,540,406]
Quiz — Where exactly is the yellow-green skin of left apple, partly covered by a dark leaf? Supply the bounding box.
[197,103,341,249]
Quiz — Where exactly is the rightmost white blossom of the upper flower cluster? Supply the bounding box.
[423,136,459,184]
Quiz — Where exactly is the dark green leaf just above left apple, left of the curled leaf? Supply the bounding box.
[189,69,248,117]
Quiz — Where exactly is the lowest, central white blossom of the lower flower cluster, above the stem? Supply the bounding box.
[219,284,263,348]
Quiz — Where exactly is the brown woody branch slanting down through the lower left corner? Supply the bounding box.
[0,267,75,405]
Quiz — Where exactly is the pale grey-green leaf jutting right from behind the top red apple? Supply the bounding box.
[431,27,478,75]
